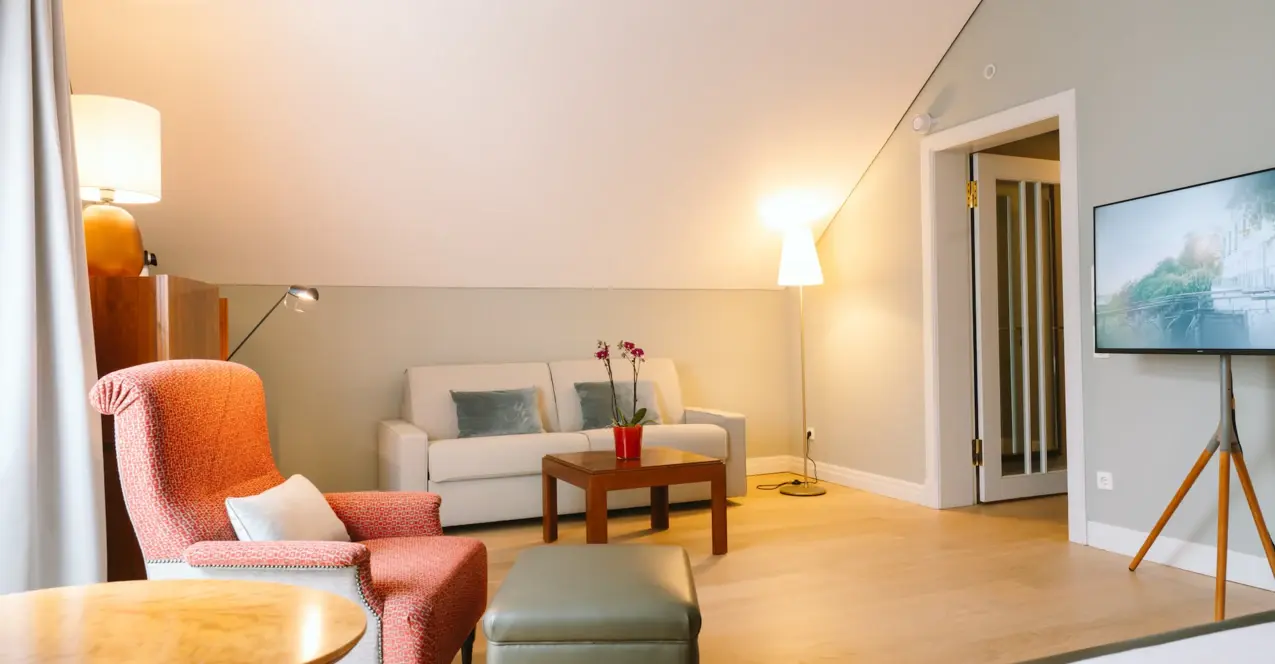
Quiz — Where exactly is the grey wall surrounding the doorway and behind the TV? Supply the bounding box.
[807,0,1275,554]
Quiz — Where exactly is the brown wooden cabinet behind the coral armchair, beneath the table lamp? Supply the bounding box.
[89,274,226,581]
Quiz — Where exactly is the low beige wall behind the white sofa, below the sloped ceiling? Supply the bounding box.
[222,285,801,491]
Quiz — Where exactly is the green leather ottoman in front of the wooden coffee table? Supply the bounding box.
[482,544,700,664]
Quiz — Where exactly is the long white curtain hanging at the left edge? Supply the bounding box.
[0,0,106,593]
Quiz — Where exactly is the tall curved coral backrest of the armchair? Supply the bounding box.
[89,359,283,561]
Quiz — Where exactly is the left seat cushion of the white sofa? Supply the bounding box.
[430,424,586,482]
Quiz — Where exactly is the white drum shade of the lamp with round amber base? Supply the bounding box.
[71,94,159,203]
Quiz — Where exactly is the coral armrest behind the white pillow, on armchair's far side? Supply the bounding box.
[324,491,442,542]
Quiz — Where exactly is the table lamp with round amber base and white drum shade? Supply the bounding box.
[71,94,159,277]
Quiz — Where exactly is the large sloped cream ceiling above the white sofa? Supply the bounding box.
[65,0,977,288]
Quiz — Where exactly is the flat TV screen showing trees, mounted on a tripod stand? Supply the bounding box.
[1094,168,1275,354]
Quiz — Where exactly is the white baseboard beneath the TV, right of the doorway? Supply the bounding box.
[1089,521,1275,590]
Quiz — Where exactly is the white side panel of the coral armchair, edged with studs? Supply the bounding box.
[147,561,381,664]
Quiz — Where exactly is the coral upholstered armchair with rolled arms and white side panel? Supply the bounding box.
[91,359,487,664]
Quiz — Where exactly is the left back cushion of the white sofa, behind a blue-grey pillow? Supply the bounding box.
[403,362,560,440]
